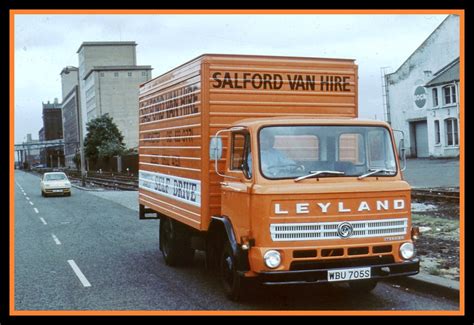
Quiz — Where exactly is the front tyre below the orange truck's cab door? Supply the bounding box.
[219,240,246,301]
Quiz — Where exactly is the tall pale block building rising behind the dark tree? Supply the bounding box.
[77,42,151,148]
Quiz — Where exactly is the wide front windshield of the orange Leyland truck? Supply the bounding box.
[258,125,396,179]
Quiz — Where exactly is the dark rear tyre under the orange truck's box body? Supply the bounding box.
[160,218,194,266]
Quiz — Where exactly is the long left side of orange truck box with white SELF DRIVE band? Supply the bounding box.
[139,58,203,229]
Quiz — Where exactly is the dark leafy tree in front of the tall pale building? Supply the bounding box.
[84,114,125,164]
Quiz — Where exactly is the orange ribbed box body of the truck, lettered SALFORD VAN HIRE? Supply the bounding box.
[139,55,357,230]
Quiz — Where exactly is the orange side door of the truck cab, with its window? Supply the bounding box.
[221,130,253,242]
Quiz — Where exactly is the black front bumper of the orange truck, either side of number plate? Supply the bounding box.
[257,258,420,285]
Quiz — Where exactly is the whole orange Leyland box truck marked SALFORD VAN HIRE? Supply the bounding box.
[139,54,419,300]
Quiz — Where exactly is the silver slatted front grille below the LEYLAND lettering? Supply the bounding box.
[270,218,408,241]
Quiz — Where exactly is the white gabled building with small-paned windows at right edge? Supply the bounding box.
[385,15,460,157]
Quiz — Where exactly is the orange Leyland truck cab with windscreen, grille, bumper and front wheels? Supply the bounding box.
[210,116,419,298]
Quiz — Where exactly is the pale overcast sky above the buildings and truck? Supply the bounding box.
[14,14,447,143]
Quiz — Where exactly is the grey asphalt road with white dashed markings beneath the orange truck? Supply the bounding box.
[14,171,459,311]
